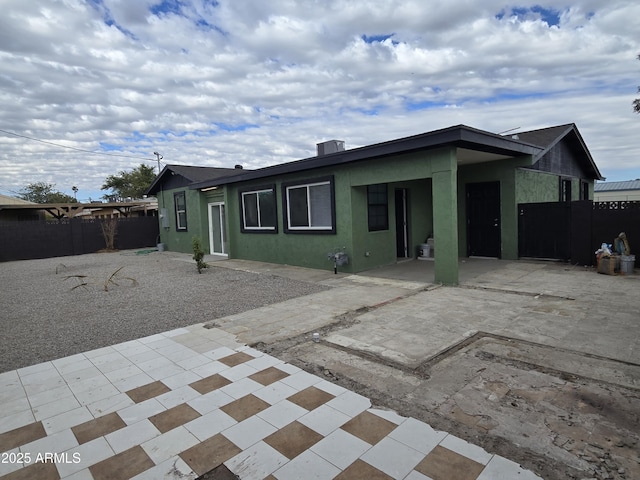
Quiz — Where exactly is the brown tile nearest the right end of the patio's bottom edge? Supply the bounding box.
[414,445,484,480]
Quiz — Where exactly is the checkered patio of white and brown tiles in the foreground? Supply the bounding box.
[0,325,538,480]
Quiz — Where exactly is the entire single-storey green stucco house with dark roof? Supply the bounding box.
[148,124,601,284]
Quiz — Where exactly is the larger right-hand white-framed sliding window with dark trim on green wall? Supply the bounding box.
[283,177,335,233]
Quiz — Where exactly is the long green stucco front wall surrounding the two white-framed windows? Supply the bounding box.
[225,150,450,275]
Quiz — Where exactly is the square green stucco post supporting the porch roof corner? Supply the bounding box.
[432,147,458,285]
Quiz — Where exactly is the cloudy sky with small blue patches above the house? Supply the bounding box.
[0,0,640,201]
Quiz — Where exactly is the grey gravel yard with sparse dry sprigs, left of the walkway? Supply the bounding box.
[0,251,328,372]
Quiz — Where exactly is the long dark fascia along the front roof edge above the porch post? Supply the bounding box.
[189,125,541,189]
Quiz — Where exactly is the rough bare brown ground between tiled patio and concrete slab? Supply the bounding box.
[258,334,640,480]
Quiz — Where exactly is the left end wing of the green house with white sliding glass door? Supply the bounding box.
[146,165,245,255]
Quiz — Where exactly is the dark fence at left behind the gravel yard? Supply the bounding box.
[0,217,159,262]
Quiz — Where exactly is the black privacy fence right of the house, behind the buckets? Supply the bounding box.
[518,200,640,267]
